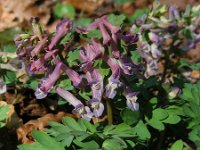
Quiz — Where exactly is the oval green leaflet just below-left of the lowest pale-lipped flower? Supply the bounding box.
[62,117,82,131]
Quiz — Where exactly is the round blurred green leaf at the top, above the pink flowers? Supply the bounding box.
[54,3,76,19]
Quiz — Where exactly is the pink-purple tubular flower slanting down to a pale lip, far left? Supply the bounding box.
[35,62,62,99]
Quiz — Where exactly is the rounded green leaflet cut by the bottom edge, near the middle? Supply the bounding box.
[102,139,123,150]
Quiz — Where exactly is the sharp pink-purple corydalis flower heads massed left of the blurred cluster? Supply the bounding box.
[15,16,143,121]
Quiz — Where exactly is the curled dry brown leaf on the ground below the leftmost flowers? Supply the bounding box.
[17,112,78,144]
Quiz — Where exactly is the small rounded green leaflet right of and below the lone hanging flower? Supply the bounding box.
[153,108,169,120]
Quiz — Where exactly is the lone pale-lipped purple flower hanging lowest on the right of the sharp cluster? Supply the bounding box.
[123,87,139,111]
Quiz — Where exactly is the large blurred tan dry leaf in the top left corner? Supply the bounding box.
[0,0,55,31]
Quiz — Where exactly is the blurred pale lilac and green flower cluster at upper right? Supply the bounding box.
[131,2,200,77]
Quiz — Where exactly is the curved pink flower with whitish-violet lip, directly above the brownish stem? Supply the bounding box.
[106,58,122,99]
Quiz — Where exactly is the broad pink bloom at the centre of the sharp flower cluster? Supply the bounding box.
[80,39,104,71]
